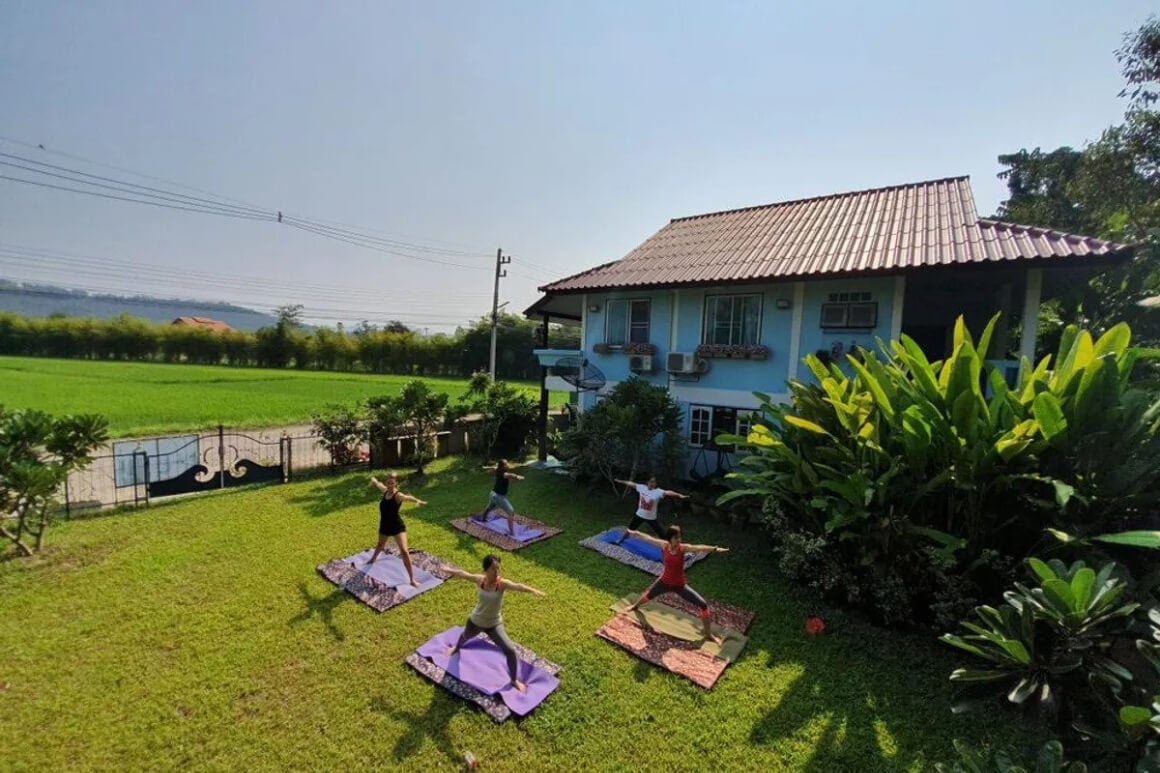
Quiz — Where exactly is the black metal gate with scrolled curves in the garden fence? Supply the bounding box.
[140,427,289,498]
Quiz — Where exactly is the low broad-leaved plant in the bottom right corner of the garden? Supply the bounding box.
[941,558,1160,771]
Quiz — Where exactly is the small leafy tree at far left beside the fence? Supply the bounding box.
[0,406,108,556]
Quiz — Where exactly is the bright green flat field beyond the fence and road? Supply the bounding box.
[0,356,567,438]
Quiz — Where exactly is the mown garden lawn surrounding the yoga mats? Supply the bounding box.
[0,461,1006,773]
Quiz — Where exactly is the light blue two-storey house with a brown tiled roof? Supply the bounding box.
[525,176,1131,477]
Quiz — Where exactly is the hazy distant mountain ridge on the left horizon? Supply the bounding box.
[0,279,276,331]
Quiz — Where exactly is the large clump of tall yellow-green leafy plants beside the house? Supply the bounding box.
[717,317,1160,624]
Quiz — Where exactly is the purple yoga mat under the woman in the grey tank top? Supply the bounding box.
[415,626,560,716]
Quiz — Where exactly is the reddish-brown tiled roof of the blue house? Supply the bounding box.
[541,178,1130,292]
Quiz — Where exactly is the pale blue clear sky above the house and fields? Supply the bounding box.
[0,0,1154,332]
